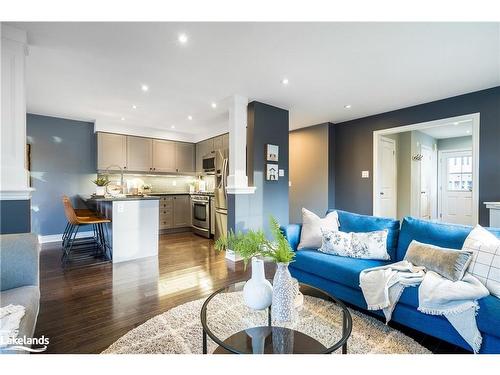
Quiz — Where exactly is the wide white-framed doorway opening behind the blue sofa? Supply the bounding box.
[373,113,479,225]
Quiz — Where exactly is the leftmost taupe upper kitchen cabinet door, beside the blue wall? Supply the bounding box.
[97,133,127,170]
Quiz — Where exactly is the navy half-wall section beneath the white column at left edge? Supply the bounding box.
[0,199,31,234]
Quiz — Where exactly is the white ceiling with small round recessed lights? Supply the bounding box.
[8,22,500,140]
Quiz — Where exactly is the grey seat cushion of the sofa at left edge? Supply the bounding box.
[0,286,40,353]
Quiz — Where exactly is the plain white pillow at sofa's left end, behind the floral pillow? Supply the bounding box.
[297,208,339,250]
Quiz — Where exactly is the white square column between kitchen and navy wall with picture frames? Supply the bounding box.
[226,95,255,194]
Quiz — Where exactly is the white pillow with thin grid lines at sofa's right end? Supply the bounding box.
[462,225,500,297]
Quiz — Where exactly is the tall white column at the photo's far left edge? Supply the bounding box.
[0,23,32,200]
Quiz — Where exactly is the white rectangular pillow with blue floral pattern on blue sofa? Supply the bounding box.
[318,229,390,260]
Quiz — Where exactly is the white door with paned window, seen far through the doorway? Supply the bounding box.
[440,150,474,225]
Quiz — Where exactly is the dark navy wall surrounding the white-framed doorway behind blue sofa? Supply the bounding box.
[330,86,500,226]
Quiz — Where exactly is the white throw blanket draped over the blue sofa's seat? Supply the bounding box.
[359,260,489,353]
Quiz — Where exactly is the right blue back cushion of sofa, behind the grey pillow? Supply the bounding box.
[396,214,500,261]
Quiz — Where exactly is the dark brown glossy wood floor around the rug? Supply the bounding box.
[35,233,461,353]
